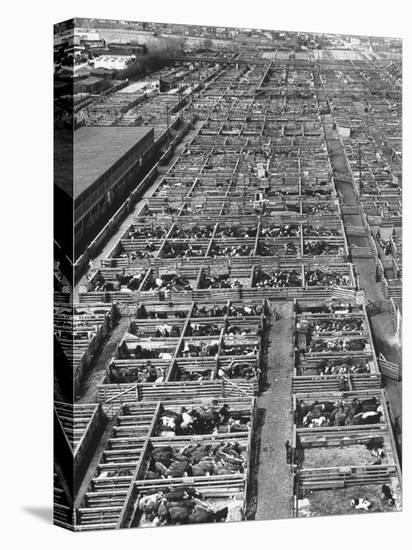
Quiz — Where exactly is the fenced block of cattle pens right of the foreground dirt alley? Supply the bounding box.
[294,302,400,516]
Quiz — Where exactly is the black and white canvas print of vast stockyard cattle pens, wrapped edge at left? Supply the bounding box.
[53,18,403,531]
